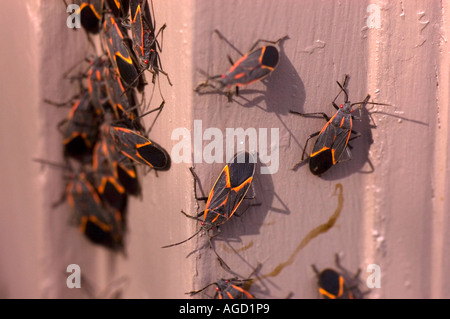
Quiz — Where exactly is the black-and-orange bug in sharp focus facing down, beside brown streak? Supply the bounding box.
[163,152,256,264]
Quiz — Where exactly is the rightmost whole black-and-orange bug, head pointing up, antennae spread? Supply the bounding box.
[290,75,388,175]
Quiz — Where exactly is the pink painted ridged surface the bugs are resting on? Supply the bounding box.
[0,0,450,298]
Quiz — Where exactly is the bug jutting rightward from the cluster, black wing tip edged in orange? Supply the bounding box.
[110,125,171,171]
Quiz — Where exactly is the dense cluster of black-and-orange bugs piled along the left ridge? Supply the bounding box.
[42,0,171,251]
